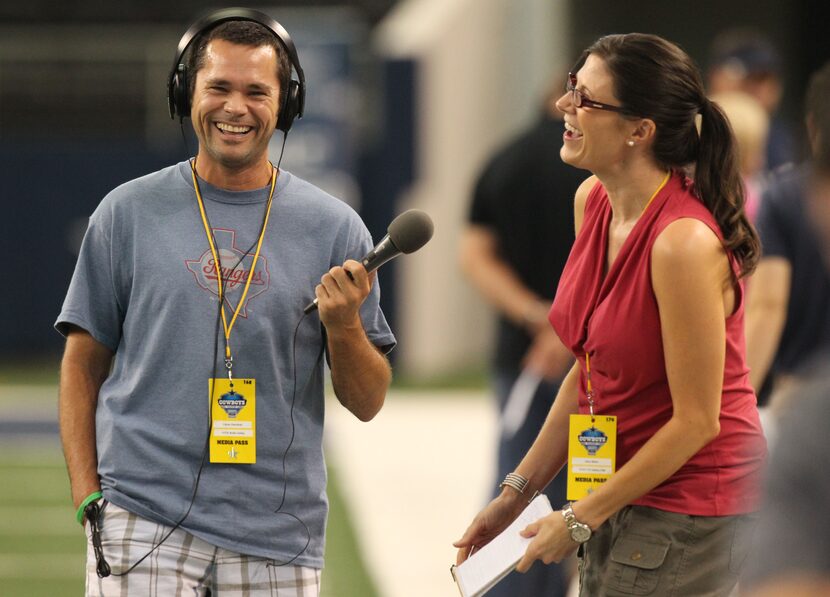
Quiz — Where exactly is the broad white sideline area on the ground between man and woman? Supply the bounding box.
[326,391,497,597]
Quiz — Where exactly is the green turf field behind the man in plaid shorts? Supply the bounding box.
[0,376,377,597]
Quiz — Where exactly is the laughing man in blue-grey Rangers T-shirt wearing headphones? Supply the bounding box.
[56,9,395,596]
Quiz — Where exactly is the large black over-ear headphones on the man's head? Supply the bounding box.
[167,8,305,133]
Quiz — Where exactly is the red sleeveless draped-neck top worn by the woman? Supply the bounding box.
[549,173,766,516]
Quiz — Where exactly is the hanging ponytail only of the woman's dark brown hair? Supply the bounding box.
[694,97,761,276]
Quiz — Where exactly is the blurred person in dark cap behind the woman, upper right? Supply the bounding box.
[708,28,798,170]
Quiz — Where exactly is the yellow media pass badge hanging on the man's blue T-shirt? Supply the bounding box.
[208,379,256,464]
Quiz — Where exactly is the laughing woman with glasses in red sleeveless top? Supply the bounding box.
[455,34,766,597]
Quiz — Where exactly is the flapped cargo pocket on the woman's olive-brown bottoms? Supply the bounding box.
[606,535,669,595]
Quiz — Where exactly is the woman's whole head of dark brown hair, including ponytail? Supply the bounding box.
[580,33,760,276]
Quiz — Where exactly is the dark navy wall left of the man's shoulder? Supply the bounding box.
[0,141,185,358]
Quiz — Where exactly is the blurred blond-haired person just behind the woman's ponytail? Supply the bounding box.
[709,91,769,222]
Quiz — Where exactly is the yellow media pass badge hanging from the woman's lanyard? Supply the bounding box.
[568,415,617,501]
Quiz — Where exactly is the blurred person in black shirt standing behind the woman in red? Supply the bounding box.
[459,80,585,597]
